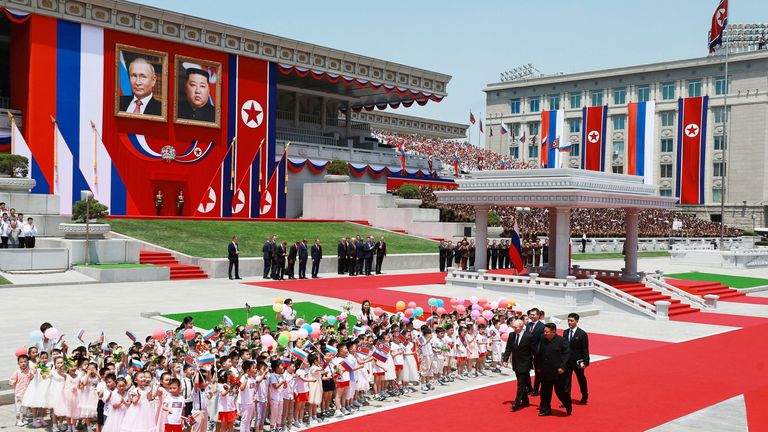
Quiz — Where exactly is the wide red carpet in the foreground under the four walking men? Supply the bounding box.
[317,322,768,432]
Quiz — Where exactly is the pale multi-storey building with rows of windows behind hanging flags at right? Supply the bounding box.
[485,50,768,229]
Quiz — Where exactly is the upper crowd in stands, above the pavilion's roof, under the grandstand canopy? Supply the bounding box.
[371,130,536,172]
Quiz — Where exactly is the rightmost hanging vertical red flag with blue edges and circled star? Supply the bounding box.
[675,96,709,204]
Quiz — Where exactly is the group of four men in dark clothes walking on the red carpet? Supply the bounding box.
[502,308,589,416]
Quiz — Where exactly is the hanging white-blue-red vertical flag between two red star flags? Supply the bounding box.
[627,101,656,184]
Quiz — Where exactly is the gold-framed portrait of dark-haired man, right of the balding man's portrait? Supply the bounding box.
[173,55,222,128]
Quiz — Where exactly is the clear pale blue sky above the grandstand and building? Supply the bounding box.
[137,0,768,144]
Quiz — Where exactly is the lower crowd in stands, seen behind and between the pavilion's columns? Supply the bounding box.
[421,187,742,237]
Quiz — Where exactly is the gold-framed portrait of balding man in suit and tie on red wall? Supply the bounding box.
[115,44,168,121]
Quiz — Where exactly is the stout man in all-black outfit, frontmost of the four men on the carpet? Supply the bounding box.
[536,323,573,416]
